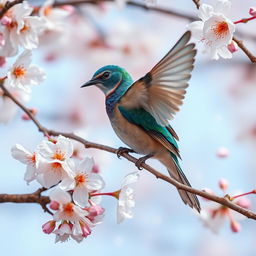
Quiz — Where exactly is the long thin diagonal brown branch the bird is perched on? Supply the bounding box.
[0,80,256,220]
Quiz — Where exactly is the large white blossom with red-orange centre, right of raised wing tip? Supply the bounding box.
[188,0,235,60]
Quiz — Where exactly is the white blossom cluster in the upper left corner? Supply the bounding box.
[0,0,69,123]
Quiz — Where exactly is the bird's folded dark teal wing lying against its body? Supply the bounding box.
[118,106,180,157]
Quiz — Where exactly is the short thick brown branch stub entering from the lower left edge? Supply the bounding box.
[0,188,53,215]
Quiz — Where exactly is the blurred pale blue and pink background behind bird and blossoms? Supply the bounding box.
[0,0,256,256]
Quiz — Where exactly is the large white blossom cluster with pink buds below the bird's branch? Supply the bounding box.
[12,135,138,242]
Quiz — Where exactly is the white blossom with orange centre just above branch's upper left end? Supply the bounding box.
[4,50,46,92]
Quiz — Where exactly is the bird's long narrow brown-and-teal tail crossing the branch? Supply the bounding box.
[161,153,201,213]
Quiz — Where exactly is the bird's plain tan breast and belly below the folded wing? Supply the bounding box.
[109,104,162,155]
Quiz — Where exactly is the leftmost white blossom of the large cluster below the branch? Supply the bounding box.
[11,144,39,184]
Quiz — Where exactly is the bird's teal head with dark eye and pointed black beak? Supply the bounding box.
[81,65,132,95]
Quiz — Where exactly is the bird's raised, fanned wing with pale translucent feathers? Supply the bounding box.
[122,31,196,126]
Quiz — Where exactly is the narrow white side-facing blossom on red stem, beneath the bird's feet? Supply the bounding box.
[117,172,139,223]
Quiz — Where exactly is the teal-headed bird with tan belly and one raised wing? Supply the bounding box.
[81,31,201,213]
